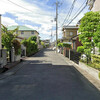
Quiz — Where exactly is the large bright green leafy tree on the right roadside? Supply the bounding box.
[79,11,100,61]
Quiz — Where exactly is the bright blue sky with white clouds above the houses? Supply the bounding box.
[0,0,89,40]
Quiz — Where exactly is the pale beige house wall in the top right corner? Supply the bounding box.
[88,0,100,12]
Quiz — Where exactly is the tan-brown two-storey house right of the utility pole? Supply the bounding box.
[62,26,78,42]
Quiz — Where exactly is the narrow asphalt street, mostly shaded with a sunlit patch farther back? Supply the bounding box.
[0,49,100,100]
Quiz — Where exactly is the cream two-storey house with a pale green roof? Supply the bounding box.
[7,26,39,43]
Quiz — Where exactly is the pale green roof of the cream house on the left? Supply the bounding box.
[7,25,36,31]
